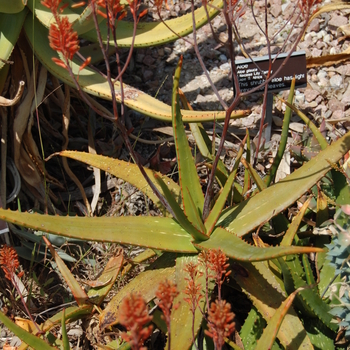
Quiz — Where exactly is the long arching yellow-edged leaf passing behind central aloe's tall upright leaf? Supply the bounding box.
[24,16,249,122]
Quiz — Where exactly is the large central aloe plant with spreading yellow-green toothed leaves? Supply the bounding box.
[0,54,350,349]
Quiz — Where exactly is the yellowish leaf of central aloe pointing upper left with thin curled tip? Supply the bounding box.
[59,151,182,208]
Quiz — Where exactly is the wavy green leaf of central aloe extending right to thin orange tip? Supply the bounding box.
[193,227,323,261]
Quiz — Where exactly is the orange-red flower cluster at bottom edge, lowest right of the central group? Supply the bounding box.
[205,300,235,349]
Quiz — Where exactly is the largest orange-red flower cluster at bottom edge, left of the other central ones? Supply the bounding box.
[119,293,153,350]
